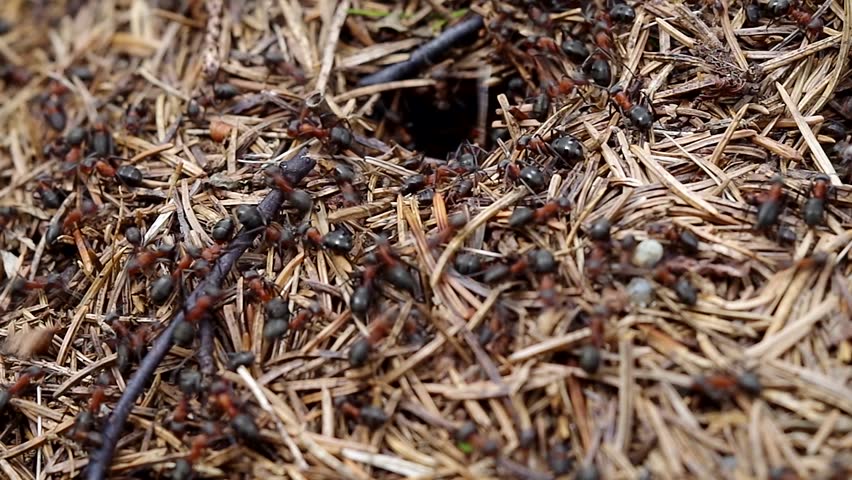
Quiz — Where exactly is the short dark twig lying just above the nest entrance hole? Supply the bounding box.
[358,15,485,87]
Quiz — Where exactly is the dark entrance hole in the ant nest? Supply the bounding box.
[376,79,506,158]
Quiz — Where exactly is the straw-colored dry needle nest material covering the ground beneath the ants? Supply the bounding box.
[0,0,852,479]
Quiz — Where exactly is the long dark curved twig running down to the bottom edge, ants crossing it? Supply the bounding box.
[86,149,316,480]
